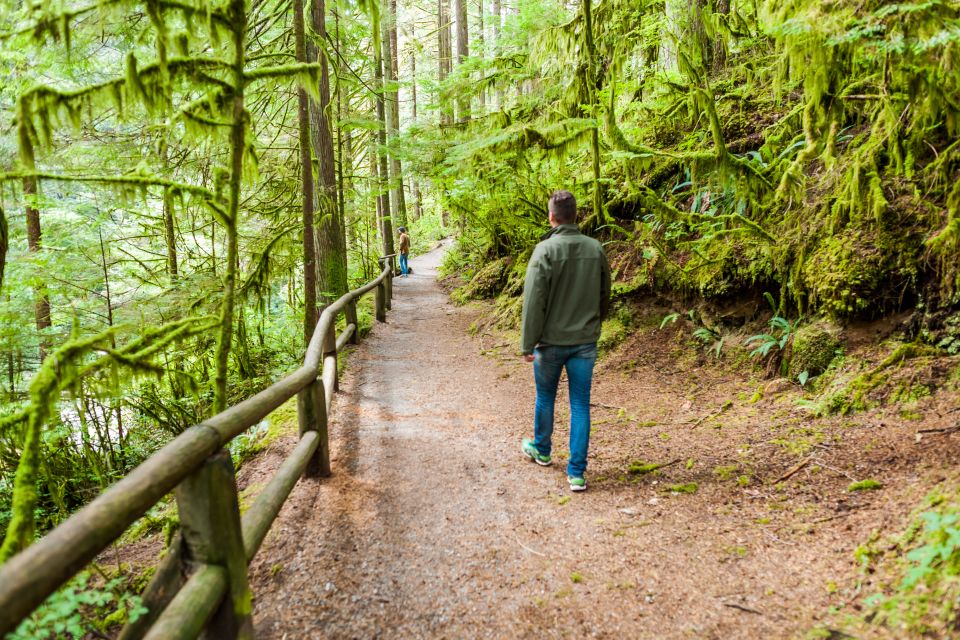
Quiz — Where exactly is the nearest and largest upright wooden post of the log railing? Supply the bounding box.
[175,449,253,639]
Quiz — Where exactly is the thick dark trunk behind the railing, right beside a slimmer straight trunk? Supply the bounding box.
[307,0,347,306]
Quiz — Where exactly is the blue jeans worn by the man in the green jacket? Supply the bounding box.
[533,342,597,478]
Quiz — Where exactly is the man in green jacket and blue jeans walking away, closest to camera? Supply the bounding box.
[520,191,610,491]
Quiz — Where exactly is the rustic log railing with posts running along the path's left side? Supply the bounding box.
[0,256,393,640]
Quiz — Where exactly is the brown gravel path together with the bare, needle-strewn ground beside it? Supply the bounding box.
[234,241,960,640]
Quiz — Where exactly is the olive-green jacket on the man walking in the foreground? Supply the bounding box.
[520,224,610,354]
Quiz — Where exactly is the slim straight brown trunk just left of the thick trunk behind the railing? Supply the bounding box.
[293,0,317,345]
